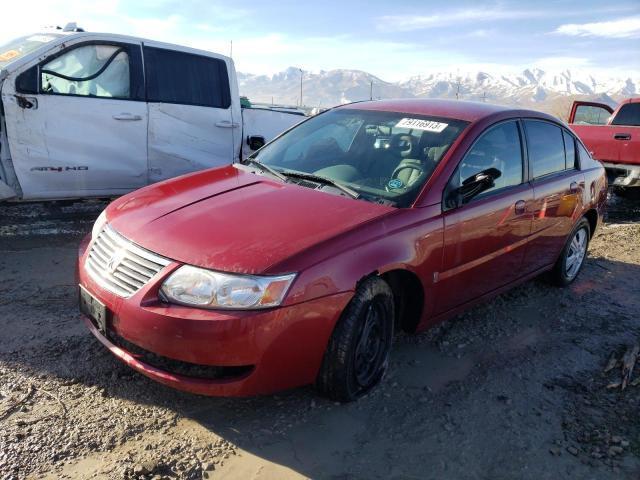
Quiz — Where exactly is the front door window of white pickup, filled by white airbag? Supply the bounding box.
[40,45,131,98]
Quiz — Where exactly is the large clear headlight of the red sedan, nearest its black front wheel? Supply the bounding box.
[160,265,295,309]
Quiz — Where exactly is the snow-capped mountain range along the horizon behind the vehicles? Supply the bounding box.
[238,67,640,116]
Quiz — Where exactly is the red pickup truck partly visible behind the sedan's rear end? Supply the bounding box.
[569,97,640,187]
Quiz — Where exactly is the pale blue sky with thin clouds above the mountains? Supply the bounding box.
[0,0,640,81]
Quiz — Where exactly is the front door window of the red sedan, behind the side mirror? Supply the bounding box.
[453,121,523,195]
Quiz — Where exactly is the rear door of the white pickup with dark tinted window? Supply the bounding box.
[144,45,235,183]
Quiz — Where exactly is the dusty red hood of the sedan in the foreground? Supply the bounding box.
[107,165,394,274]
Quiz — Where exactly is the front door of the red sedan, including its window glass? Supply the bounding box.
[436,121,533,313]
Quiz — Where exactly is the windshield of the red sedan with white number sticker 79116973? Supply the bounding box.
[253,108,467,207]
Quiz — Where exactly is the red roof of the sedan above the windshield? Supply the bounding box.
[340,98,545,122]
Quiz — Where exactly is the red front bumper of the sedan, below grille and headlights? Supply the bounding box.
[78,234,352,396]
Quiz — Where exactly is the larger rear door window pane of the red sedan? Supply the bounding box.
[524,120,566,179]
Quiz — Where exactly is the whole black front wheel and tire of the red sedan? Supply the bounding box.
[316,277,395,402]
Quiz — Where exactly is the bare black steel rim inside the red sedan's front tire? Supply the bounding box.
[355,298,386,388]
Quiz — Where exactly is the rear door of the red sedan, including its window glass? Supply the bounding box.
[524,119,584,271]
